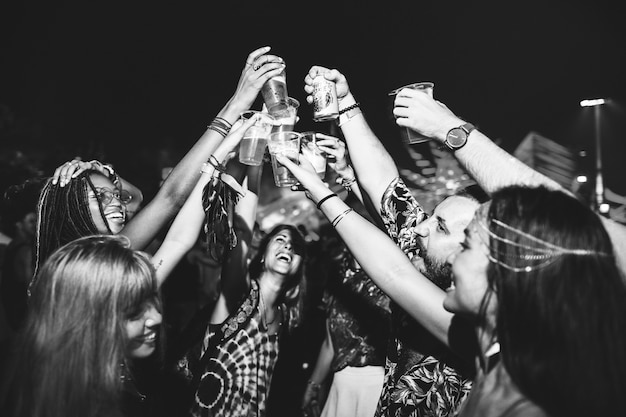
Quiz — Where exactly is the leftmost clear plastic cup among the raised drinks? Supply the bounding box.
[239,110,273,166]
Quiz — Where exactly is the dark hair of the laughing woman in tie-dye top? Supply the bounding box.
[248,224,307,330]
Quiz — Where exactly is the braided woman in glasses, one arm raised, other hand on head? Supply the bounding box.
[34,47,284,283]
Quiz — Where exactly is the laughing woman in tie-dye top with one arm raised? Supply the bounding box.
[176,169,306,416]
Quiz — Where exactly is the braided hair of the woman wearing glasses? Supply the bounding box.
[31,170,113,285]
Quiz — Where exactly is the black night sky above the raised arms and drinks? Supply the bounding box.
[0,0,626,195]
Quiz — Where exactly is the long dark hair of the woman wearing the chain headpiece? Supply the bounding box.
[487,187,626,416]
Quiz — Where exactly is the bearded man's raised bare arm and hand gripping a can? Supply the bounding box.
[304,66,399,212]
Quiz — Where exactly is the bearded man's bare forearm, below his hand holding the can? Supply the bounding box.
[341,94,399,211]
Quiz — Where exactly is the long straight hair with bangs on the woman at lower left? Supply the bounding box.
[0,235,160,417]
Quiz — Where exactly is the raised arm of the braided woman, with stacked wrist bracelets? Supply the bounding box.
[121,47,284,249]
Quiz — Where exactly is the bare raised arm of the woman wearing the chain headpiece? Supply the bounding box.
[278,156,453,344]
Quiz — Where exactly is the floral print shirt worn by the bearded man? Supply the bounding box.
[376,178,473,417]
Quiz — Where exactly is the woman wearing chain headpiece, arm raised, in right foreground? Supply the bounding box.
[279,151,626,417]
